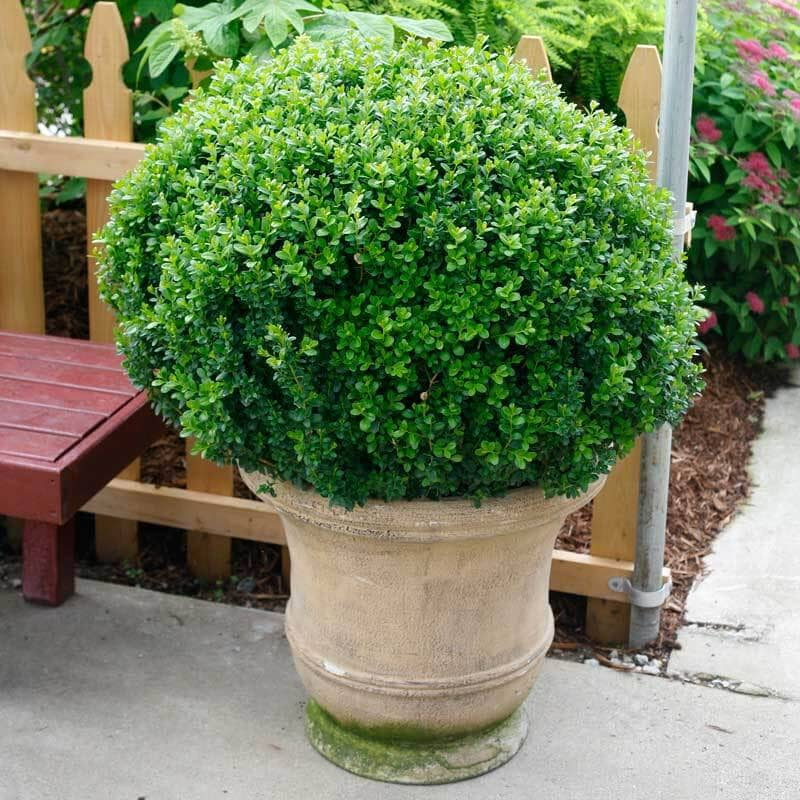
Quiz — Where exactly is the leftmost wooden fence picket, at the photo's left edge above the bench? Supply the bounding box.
[0,0,44,333]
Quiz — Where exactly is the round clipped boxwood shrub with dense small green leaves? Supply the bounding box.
[100,39,699,507]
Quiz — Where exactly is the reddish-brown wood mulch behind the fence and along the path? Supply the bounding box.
[0,209,780,660]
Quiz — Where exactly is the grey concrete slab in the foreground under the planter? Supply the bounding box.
[0,581,800,800]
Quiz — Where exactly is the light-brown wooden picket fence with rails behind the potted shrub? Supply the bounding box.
[0,0,668,642]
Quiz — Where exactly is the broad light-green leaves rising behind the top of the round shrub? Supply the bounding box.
[139,0,453,78]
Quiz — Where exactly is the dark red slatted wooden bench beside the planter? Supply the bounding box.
[0,331,164,605]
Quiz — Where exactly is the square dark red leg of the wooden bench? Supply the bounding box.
[22,517,75,606]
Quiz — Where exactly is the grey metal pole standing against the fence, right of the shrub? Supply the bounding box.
[629,0,697,647]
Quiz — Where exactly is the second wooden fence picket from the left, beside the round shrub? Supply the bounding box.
[83,2,139,561]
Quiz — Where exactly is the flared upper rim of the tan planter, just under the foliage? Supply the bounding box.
[239,468,606,541]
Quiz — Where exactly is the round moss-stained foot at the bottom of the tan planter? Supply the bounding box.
[306,699,528,784]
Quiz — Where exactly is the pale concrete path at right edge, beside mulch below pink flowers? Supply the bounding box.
[669,370,800,700]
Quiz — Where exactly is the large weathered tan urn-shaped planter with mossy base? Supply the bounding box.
[243,473,602,783]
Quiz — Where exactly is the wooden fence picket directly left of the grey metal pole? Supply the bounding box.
[586,45,661,643]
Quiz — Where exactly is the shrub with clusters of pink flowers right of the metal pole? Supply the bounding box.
[689,0,800,361]
